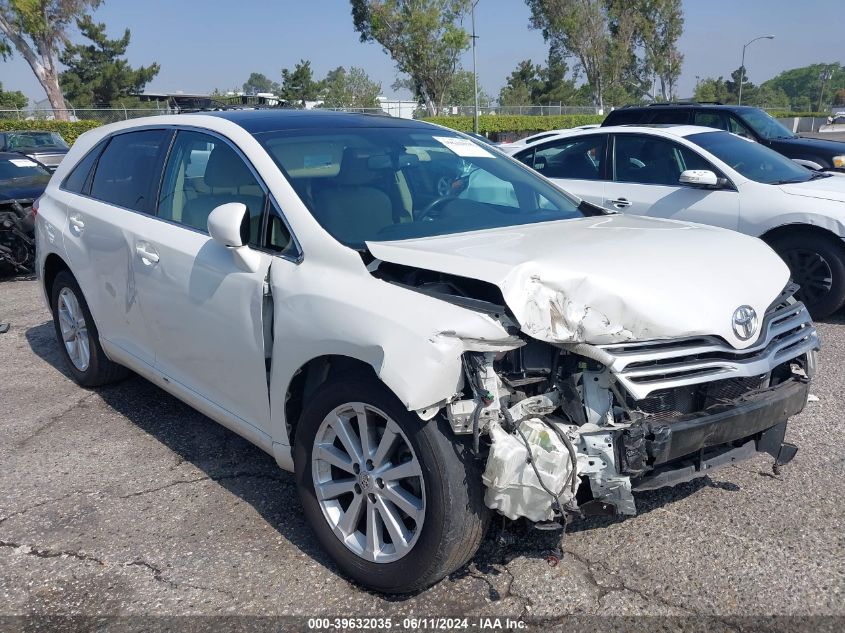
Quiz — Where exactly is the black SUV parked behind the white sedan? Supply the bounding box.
[602,102,845,172]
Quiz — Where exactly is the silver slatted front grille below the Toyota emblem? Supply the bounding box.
[599,302,819,401]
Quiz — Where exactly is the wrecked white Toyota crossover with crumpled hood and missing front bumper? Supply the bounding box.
[36,111,819,592]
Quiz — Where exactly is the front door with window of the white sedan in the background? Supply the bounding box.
[603,133,739,229]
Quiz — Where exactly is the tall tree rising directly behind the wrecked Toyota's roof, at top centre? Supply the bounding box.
[350,0,471,116]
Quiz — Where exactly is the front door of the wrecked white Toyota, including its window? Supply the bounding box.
[135,131,273,434]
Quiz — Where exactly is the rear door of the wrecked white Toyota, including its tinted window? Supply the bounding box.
[62,129,172,366]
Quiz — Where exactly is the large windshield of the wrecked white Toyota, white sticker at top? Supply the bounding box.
[255,128,584,249]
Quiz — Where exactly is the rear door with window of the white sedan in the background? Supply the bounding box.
[516,134,608,206]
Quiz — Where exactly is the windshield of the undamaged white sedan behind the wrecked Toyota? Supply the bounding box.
[687,132,814,185]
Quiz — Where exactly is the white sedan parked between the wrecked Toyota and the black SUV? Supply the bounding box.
[514,125,845,318]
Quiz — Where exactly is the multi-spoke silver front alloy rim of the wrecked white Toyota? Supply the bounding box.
[311,402,425,563]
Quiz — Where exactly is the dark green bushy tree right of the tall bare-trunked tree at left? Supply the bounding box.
[59,15,160,108]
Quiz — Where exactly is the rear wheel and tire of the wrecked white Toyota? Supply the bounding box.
[50,270,130,387]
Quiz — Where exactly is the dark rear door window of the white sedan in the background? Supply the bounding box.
[526,134,607,180]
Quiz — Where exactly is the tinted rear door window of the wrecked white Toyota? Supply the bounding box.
[91,130,171,213]
